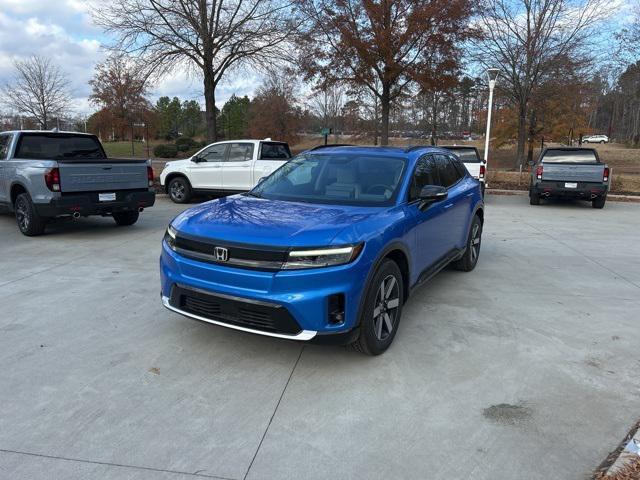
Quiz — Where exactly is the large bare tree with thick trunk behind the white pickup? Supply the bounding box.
[93,0,296,141]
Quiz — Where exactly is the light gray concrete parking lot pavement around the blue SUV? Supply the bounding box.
[0,196,640,480]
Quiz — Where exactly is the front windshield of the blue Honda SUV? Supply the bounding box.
[249,153,405,206]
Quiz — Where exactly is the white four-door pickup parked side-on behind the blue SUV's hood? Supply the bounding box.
[160,138,291,203]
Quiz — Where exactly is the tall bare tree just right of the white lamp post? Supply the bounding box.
[476,0,609,167]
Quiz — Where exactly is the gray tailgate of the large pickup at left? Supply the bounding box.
[58,160,149,193]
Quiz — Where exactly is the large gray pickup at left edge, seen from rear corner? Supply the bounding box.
[0,130,155,236]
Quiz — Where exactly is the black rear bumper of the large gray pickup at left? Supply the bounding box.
[34,190,156,217]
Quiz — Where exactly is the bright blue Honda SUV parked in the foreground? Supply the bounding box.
[160,146,484,355]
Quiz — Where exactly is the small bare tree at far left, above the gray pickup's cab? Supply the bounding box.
[2,55,71,130]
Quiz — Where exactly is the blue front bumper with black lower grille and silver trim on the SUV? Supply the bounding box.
[160,242,370,344]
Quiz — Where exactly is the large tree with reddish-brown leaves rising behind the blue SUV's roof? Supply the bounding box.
[297,0,476,145]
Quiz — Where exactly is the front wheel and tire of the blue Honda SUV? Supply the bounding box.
[351,259,404,355]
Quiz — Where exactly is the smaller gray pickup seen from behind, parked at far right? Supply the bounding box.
[529,147,610,208]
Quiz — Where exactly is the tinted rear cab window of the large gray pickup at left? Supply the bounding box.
[15,133,105,160]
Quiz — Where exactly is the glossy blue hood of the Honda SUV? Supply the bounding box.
[172,195,382,247]
